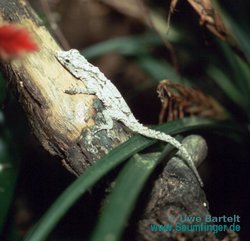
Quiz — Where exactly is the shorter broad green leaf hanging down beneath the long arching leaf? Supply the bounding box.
[91,145,176,241]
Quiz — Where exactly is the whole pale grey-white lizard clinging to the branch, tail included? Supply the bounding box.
[55,49,203,186]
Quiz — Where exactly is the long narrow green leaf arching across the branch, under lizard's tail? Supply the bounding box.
[25,118,240,241]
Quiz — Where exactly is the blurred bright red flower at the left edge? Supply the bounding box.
[0,24,38,59]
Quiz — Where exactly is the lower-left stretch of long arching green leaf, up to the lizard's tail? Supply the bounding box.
[25,133,155,241]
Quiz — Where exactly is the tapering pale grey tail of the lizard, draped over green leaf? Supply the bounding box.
[137,124,203,187]
